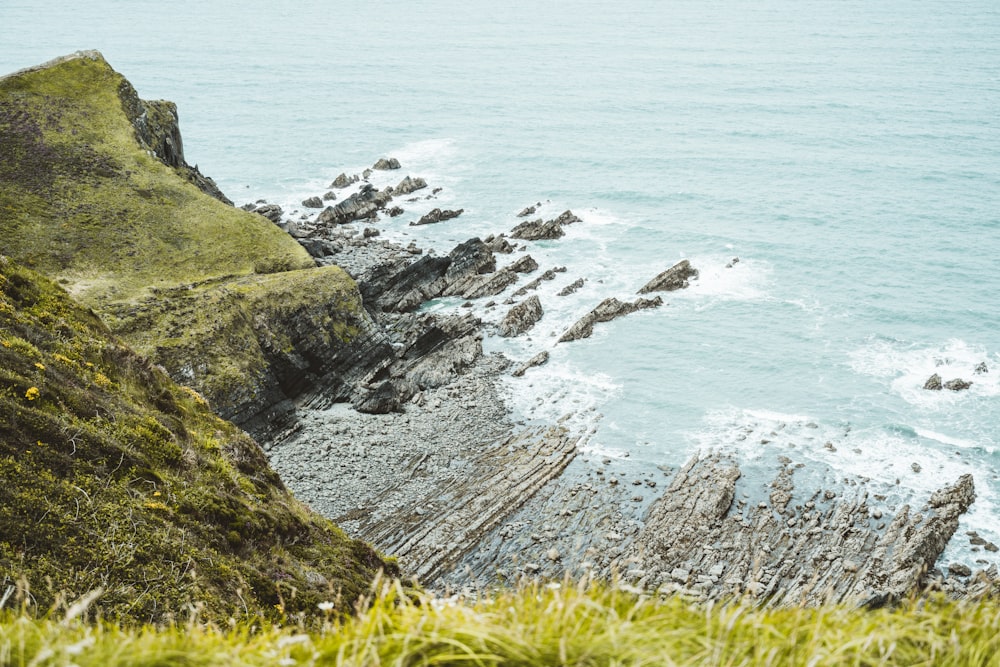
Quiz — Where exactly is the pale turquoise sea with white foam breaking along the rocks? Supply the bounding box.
[0,0,1000,563]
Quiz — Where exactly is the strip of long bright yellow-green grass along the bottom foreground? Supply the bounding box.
[0,583,1000,667]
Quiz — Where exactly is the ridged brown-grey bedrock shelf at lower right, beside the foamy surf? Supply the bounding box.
[632,453,975,606]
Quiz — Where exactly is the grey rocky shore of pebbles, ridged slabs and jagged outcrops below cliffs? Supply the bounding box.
[240,159,997,605]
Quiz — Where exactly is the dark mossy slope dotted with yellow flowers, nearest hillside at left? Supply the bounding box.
[0,256,392,628]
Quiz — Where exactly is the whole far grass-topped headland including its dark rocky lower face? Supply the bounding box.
[0,51,380,425]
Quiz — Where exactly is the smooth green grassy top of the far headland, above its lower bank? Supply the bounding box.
[0,51,313,308]
